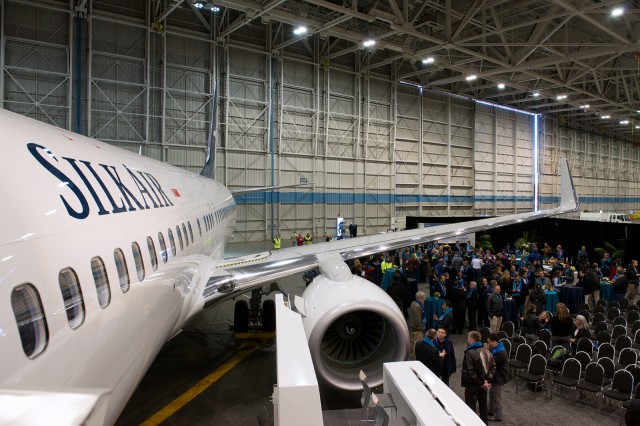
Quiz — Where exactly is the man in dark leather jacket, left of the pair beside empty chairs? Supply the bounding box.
[460,331,496,424]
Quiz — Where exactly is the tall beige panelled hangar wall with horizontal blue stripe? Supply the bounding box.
[0,0,640,241]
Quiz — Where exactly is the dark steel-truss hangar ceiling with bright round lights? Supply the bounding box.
[144,0,640,142]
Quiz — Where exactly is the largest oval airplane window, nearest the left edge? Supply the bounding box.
[11,283,49,359]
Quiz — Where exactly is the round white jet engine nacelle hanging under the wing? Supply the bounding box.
[302,275,409,391]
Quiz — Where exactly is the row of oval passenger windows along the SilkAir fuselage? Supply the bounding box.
[11,206,235,359]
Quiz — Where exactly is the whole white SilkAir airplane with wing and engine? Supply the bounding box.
[0,104,579,424]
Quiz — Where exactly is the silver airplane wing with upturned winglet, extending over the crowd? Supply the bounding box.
[203,160,579,307]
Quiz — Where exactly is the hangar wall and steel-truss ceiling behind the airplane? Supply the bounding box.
[0,0,640,424]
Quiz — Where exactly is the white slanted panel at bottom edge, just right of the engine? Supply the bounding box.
[383,361,484,426]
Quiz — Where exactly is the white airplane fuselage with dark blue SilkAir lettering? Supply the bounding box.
[0,110,235,424]
